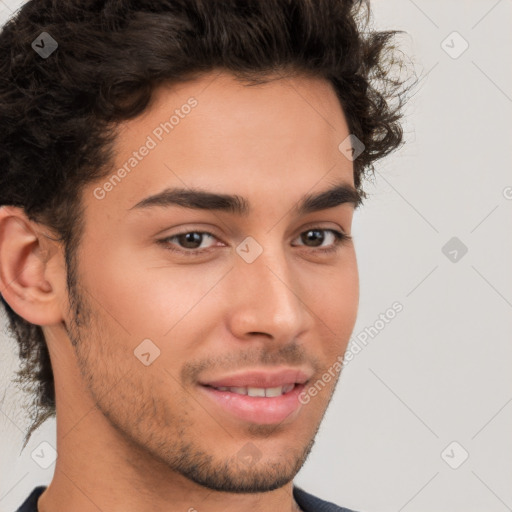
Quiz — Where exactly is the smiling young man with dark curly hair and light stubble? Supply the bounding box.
[0,0,414,512]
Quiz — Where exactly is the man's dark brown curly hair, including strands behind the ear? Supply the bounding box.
[0,0,416,447]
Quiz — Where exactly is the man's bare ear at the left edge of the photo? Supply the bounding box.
[0,206,65,325]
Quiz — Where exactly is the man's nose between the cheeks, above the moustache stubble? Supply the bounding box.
[228,244,314,344]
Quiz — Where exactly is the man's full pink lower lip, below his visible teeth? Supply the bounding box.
[201,384,305,425]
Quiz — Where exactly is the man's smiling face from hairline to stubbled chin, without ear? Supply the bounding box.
[56,74,358,492]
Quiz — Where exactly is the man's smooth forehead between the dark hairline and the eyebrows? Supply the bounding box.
[85,69,353,218]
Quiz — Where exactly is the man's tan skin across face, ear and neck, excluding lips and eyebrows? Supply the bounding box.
[0,73,359,512]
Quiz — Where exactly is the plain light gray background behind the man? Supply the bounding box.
[0,0,512,512]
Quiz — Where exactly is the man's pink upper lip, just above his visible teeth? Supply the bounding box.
[200,368,312,388]
